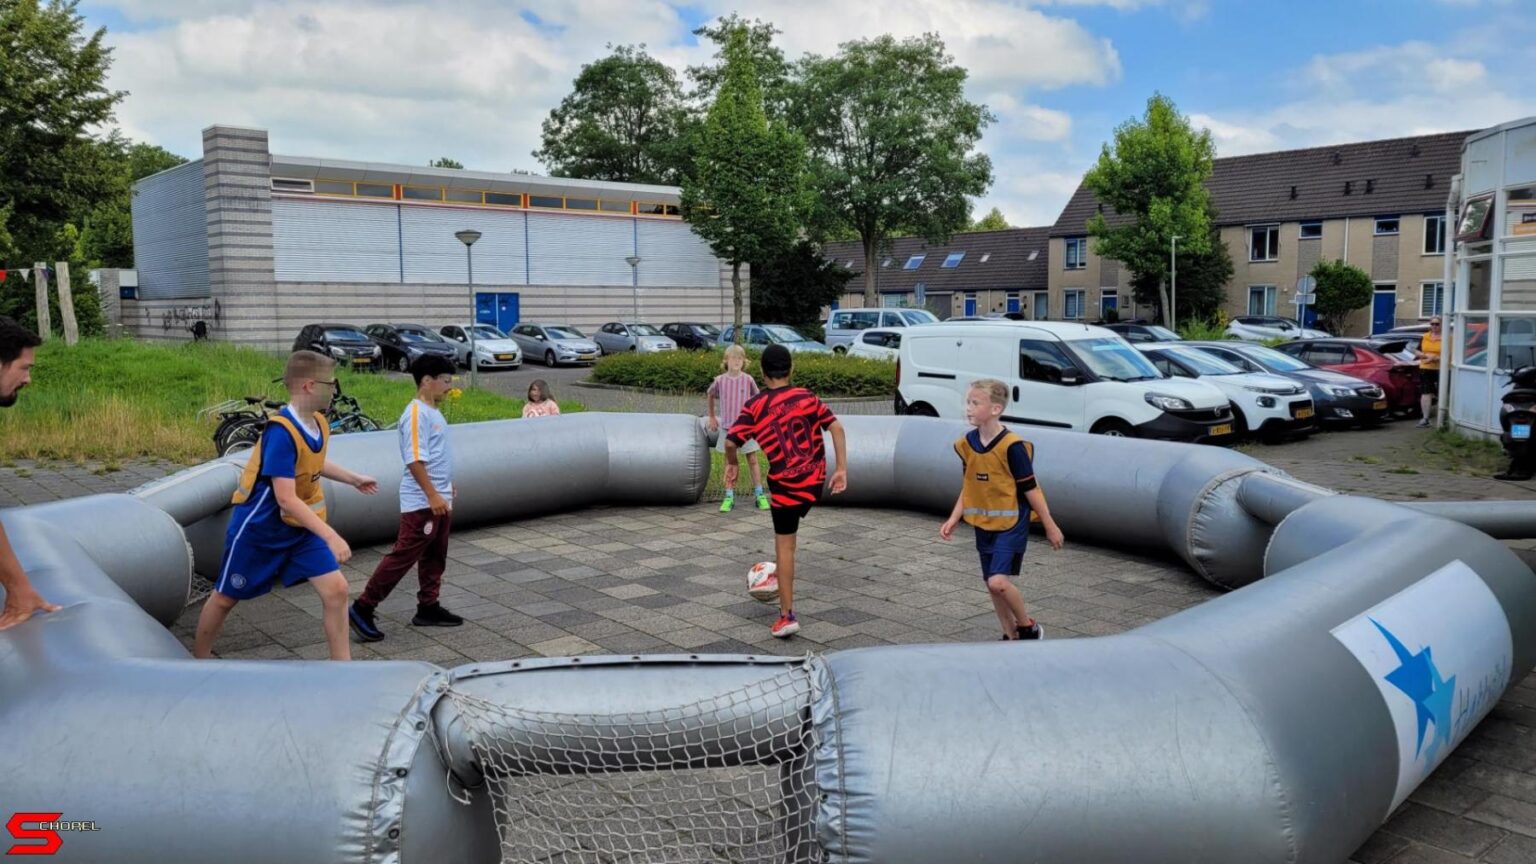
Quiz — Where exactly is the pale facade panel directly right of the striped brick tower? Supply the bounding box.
[272,200,401,283]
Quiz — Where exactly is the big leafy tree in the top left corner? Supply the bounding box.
[0,0,124,263]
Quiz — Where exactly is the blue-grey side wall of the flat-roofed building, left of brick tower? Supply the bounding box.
[134,160,209,300]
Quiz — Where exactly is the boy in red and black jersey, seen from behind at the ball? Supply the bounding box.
[725,344,848,638]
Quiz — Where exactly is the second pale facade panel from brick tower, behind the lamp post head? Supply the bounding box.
[399,208,528,286]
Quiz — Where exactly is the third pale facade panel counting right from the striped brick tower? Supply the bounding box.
[528,212,645,286]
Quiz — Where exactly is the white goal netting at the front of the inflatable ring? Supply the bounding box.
[449,667,822,864]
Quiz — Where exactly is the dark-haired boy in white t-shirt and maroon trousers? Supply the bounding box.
[347,354,464,643]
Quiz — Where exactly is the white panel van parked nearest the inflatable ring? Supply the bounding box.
[895,321,1236,441]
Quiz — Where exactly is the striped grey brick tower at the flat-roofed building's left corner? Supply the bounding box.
[203,126,279,347]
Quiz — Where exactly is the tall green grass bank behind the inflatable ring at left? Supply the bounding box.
[0,340,582,466]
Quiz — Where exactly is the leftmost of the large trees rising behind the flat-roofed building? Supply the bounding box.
[533,45,684,184]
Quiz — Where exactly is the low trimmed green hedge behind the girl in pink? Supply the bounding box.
[591,344,895,397]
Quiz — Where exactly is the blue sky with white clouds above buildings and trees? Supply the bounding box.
[80,0,1536,224]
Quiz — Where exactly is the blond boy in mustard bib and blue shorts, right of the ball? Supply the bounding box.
[938,378,1064,641]
